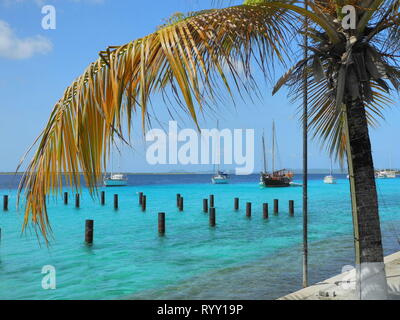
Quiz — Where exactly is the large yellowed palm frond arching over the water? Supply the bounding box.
[19,5,297,241]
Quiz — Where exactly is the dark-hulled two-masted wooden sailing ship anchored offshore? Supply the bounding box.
[260,121,294,188]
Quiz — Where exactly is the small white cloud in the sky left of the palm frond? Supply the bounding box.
[0,20,53,59]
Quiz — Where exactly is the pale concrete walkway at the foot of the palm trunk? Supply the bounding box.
[278,252,400,300]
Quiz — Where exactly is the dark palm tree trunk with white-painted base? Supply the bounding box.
[344,100,387,299]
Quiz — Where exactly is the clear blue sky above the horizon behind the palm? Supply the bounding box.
[0,0,400,172]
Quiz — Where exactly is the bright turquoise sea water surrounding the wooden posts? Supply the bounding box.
[0,176,400,299]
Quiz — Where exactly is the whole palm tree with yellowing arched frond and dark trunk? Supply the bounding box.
[19,0,400,298]
